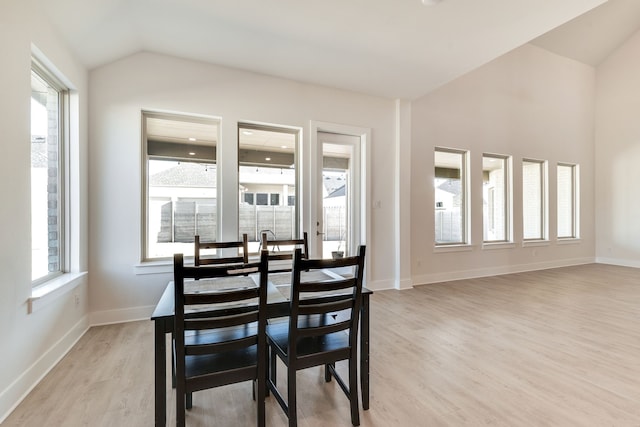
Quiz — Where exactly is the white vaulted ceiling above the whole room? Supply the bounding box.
[35,0,640,99]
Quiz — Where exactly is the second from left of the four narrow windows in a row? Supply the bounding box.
[482,154,511,242]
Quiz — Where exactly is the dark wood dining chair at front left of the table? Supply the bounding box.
[174,251,268,427]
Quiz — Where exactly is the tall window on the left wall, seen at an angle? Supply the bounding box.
[31,60,69,284]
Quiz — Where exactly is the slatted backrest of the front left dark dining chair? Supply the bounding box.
[174,251,268,390]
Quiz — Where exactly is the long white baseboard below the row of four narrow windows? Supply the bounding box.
[413,257,596,286]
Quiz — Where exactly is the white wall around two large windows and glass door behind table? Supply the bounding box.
[89,53,395,323]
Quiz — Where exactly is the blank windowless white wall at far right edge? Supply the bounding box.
[595,33,640,267]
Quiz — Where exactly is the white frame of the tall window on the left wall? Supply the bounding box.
[30,56,71,288]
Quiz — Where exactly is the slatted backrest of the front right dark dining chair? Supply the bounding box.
[289,245,365,363]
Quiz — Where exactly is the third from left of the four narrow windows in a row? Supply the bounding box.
[522,160,547,240]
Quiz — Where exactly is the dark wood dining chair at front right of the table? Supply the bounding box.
[267,246,365,427]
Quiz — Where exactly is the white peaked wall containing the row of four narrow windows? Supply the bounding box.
[411,45,595,284]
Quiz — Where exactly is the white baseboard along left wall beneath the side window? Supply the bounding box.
[0,316,89,424]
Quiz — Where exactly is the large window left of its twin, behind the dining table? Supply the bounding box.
[142,112,219,260]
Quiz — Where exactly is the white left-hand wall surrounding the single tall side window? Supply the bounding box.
[0,0,88,421]
